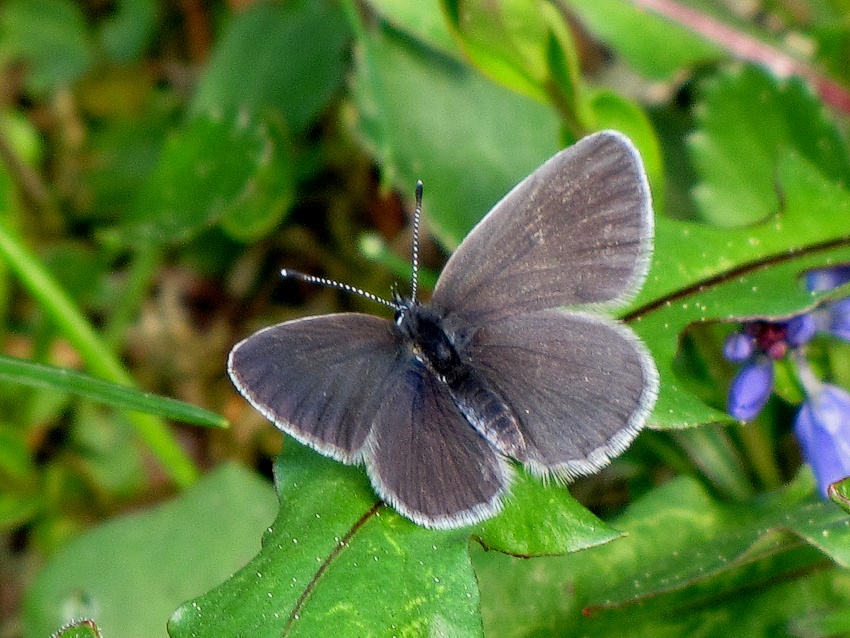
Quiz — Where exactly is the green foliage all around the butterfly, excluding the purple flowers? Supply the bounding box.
[0,0,850,638]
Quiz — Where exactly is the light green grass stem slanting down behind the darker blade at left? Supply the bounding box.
[0,224,198,487]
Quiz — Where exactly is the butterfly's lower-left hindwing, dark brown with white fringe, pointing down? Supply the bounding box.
[364,360,510,528]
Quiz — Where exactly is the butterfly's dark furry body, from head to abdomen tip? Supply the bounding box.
[395,300,526,461]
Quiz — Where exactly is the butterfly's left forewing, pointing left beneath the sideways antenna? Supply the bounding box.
[228,313,402,463]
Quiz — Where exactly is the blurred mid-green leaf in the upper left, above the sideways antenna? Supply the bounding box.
[123,116,292,245]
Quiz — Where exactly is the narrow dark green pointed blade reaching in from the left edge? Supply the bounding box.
[0,355,227,428]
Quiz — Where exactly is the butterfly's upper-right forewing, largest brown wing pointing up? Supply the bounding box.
[432,131,652,326]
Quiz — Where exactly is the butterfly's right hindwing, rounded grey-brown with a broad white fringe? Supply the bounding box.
[467,310,658,478]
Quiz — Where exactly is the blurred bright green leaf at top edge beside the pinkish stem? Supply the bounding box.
[567,0,724,80]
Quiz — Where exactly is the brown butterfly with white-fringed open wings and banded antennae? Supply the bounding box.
[228,131,658,529]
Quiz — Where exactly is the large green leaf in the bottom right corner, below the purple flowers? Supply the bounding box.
[473,478,850,637]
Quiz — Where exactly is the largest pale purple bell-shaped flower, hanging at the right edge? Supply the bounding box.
[794,384,850,497]
